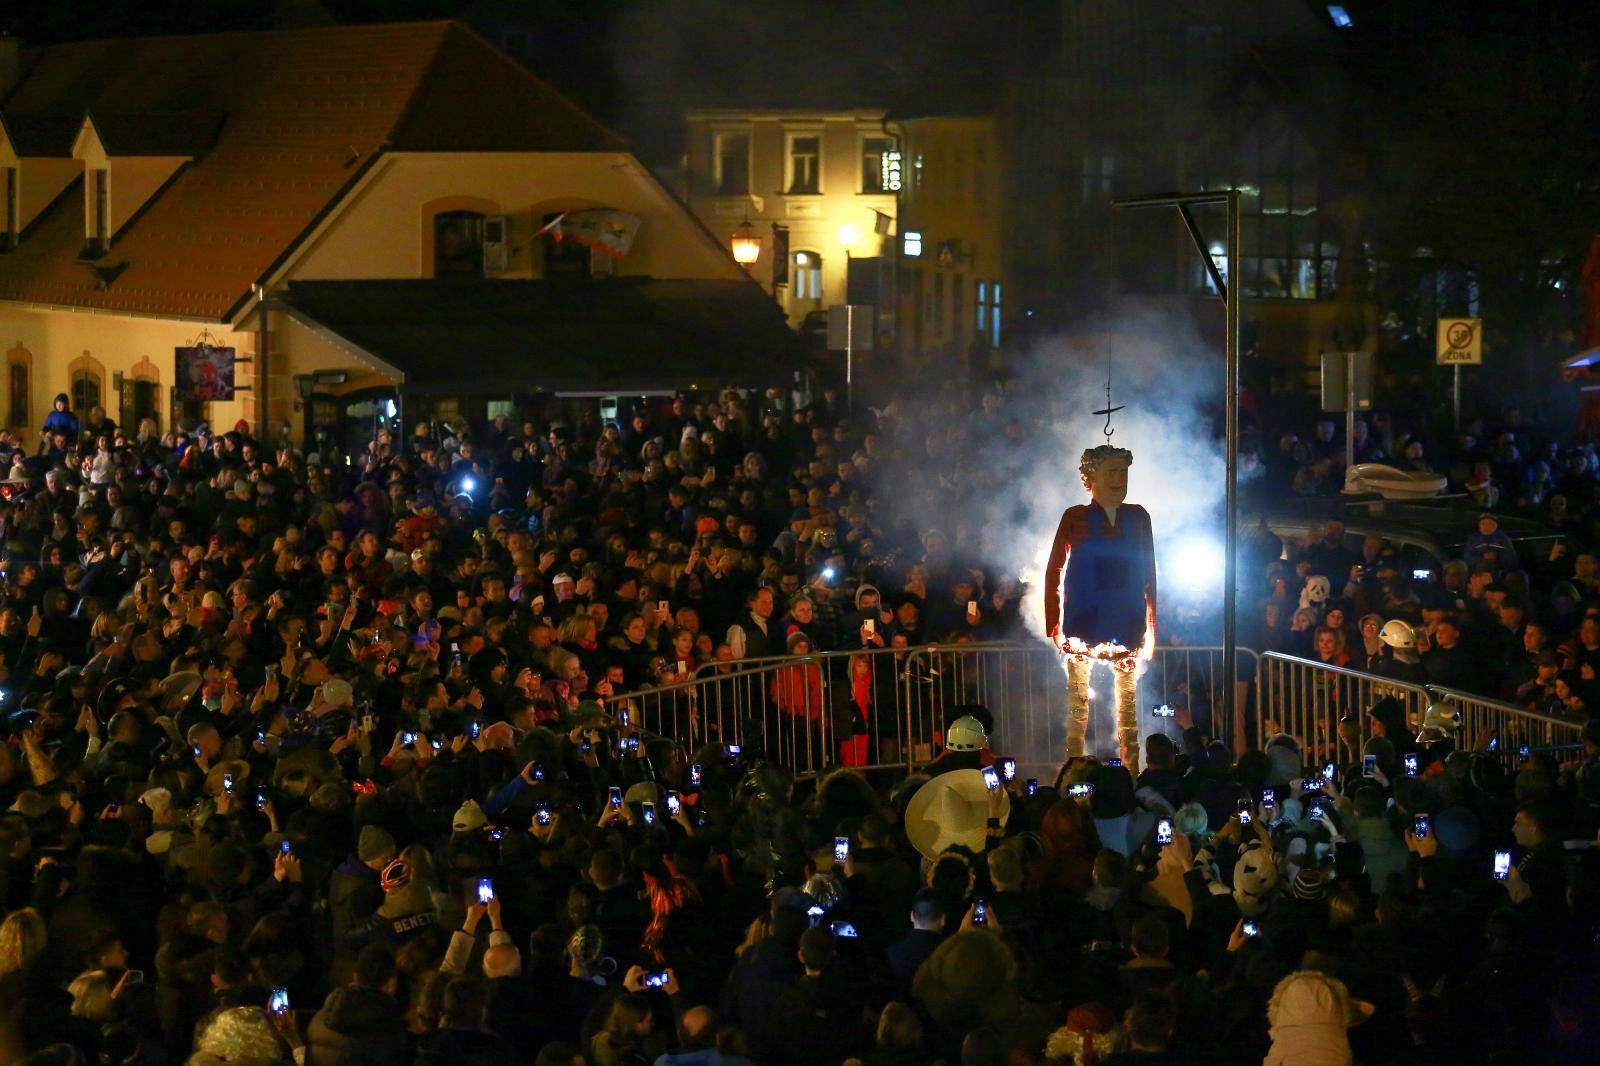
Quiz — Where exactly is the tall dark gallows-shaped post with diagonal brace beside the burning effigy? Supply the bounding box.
[1110,189,1245,752]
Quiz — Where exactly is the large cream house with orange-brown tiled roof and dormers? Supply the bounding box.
[0,22,776,440]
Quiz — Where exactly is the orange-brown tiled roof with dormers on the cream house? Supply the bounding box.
[0,22,626,320]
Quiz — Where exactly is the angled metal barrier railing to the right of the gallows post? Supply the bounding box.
[1251,651,1582,762]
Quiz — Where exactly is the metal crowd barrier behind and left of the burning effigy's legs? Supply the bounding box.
[608,642,1258,779]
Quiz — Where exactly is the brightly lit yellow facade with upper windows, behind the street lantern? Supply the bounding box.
[683,109,904,327]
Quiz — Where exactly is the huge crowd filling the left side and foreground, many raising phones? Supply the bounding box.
[0,387,1600,1066]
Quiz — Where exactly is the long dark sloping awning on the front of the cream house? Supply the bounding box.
[285,277,805,394]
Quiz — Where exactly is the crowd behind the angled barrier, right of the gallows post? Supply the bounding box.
[1243,411,1600,722]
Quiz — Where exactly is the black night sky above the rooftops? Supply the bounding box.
[0,0,1491,158]
